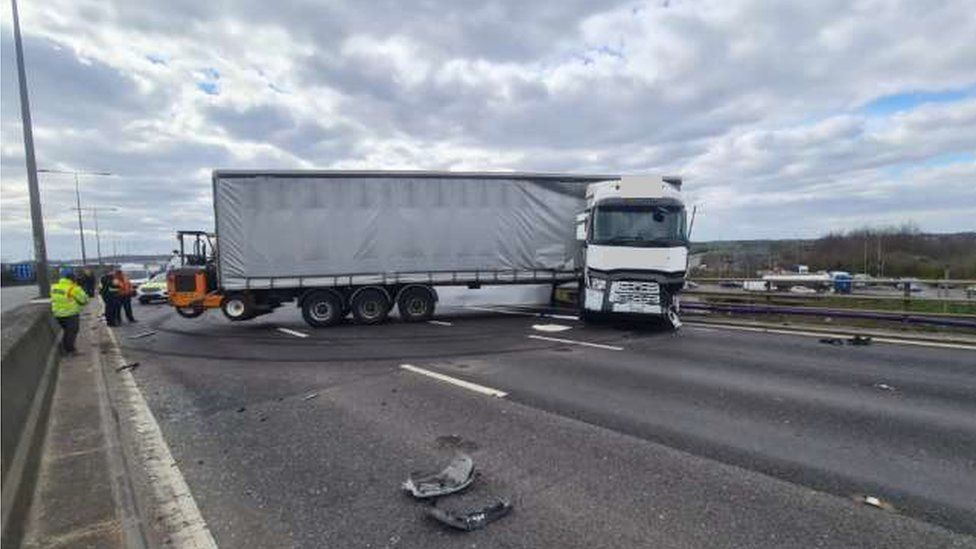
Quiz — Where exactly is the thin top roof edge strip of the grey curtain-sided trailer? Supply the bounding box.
[213,169,621,183]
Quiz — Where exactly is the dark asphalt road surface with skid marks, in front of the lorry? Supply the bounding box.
[110,298,976,547]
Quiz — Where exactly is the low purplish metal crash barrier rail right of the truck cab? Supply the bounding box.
[681,301,976,329]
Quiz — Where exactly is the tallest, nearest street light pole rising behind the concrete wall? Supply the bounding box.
[11,0,51,297]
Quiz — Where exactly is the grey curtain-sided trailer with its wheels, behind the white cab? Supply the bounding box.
[178,170,619,326]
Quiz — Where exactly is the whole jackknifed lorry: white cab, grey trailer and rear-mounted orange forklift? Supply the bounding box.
[167,170,688,327]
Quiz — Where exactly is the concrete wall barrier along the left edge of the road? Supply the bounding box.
[0,303,61,547]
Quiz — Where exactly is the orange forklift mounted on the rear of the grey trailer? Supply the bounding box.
[166,231,223,318]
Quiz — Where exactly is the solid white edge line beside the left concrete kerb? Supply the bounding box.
[108,330,217,549]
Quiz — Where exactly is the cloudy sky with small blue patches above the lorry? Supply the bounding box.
[0,0,976,259]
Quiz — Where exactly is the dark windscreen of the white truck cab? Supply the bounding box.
[590,204,688,247]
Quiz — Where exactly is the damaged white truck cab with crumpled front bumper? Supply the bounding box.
[577,176,688,328]
